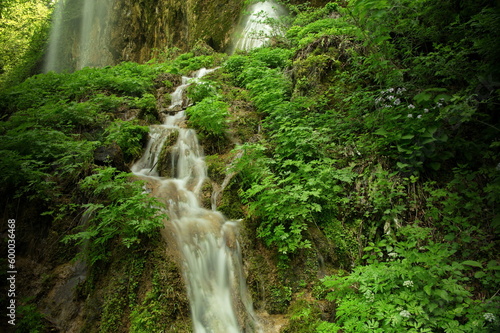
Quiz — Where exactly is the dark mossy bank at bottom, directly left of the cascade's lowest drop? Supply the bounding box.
[82,235,191,333]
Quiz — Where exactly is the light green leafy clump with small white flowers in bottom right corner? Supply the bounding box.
[319,226,498,332]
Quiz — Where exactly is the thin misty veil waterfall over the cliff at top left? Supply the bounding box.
[43,0,114,73]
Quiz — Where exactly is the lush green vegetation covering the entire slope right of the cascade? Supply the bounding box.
[223,0,500,324]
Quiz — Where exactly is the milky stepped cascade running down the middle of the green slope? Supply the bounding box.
[132,69,260,333]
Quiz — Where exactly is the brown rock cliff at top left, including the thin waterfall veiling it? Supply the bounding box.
[46,0,243,71]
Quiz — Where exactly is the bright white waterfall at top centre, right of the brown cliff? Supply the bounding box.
[230,0,286,53]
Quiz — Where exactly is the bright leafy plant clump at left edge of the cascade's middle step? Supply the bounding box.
[63,167,166,264]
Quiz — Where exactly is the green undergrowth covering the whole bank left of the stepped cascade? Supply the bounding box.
[0,54,221,332]
